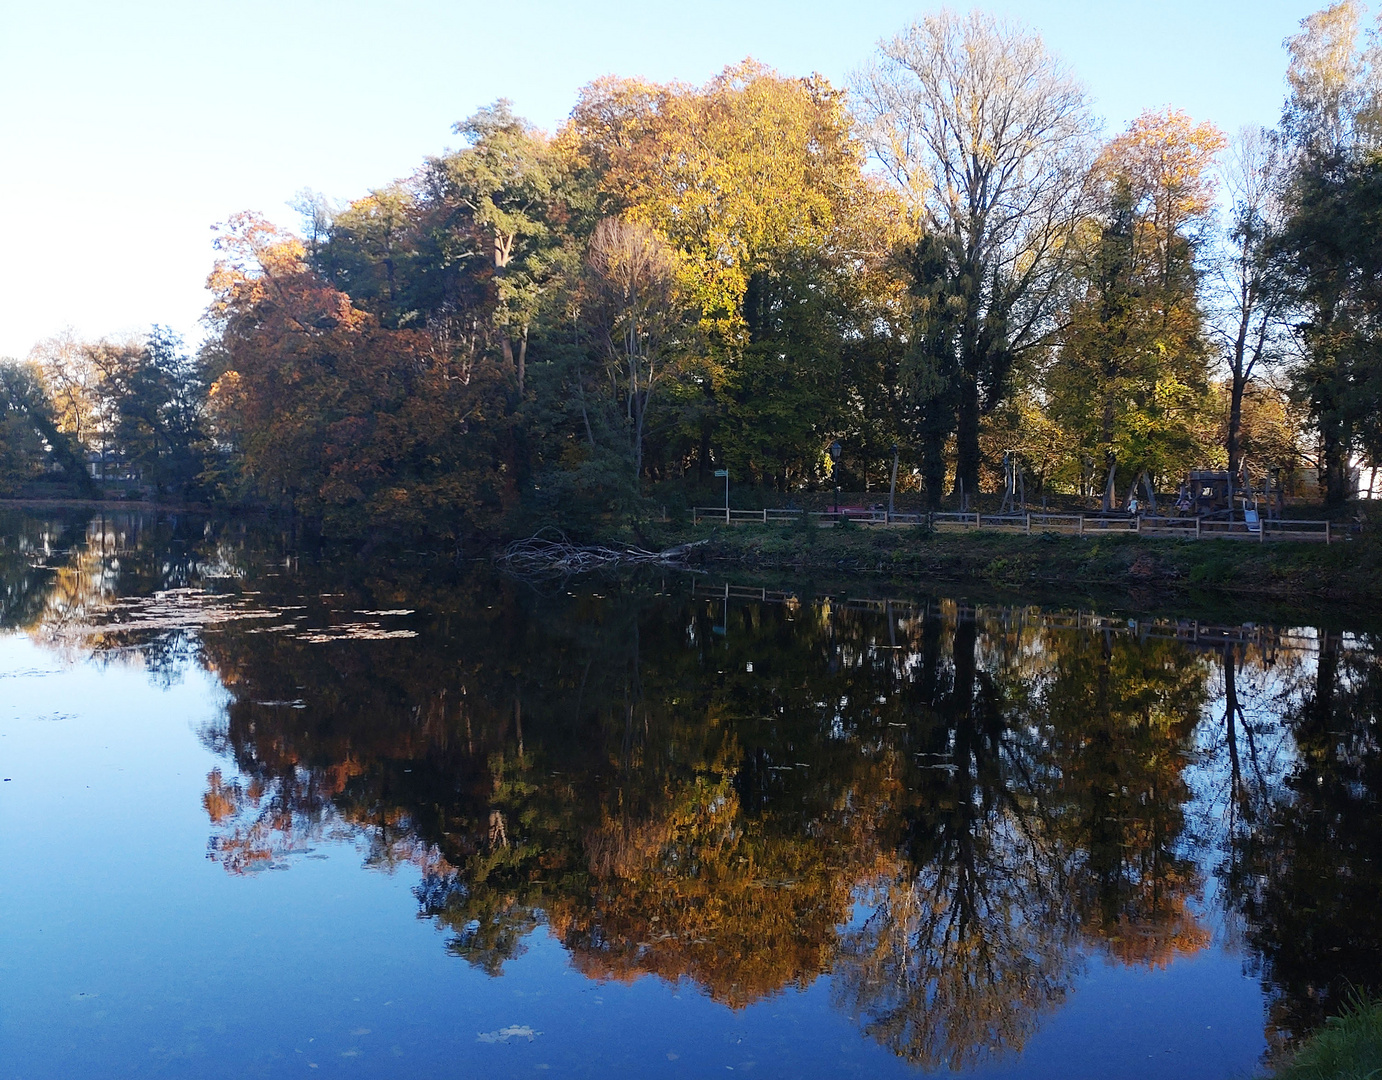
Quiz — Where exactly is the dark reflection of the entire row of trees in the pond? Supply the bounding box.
[10,508,1382,1066]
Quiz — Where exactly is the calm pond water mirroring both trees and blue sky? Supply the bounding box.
[0,513,1382,1077]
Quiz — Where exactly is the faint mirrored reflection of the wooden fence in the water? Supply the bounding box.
[692,582,1318,649]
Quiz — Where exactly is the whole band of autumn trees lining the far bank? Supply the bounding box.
[0,0,1382,542]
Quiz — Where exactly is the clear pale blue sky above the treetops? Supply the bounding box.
[0,0,1323,355]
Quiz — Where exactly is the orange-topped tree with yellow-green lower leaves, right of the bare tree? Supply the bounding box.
[1046,109,1224,510]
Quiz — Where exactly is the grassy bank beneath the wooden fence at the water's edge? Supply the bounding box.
[643,524,1382,607]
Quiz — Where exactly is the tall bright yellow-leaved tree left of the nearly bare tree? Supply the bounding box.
[562,61,891,480]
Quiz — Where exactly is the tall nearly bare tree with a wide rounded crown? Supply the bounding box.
[854,11,1093,498]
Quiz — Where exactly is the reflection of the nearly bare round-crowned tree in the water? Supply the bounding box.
[836,613,1078,1069]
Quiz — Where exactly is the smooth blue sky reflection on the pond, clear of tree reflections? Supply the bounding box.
[0,636,1263,1077]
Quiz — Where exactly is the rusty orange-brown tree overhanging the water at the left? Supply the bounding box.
[207,214,504,537]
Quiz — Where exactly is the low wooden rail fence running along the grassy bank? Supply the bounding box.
[691,506,1334,543]
